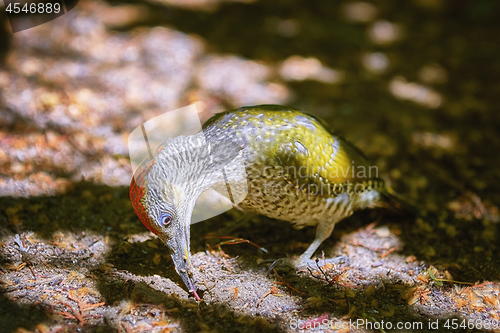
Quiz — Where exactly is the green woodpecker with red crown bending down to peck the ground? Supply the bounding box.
[129,105,398,300]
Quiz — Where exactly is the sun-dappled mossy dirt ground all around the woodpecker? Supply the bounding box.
[0,0,500,333]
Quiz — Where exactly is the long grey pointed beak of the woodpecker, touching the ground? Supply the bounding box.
[166,225,200,301]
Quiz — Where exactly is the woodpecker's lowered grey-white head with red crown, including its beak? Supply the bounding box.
[129,135,241,299]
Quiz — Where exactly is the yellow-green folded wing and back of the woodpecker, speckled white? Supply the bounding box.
[203,105,377,192]
